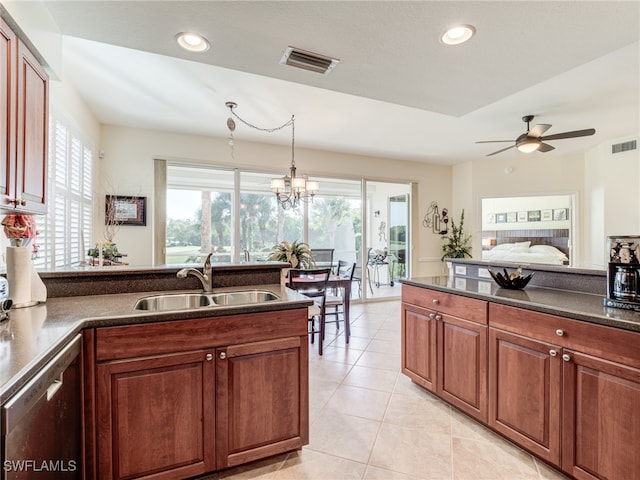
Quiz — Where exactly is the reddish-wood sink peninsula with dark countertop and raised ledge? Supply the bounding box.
[0,264,311,478]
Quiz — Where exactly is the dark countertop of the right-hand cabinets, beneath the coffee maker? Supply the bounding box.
[400,276,640,332]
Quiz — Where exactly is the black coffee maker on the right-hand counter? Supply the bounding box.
[605,235,640,312]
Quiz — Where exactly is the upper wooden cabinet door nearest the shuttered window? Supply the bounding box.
[15,42,49,213]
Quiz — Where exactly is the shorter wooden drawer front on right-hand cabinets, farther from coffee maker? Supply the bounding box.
[402,285,488,324]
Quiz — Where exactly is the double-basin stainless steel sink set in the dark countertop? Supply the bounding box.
[133,290,280,312]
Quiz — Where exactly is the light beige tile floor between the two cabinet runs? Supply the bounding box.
[201,300,566,480]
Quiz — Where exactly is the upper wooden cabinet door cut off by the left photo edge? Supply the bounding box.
[0,18,17,206]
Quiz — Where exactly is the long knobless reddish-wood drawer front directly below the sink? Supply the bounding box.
[96,307,307,362]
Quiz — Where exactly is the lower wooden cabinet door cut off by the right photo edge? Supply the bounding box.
[562,350,640,480]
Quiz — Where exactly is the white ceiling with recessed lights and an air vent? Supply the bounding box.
[42,0,640,165]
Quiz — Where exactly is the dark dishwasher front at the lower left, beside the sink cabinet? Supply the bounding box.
[2,335,82,480]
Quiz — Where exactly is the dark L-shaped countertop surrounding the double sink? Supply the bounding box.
[0,284,312,404]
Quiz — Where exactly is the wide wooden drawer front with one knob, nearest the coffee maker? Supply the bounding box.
[489,303,640,367]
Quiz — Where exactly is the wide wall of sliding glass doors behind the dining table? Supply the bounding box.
[165,162,410,300]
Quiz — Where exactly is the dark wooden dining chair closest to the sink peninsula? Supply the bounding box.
[287,268,331,355]
